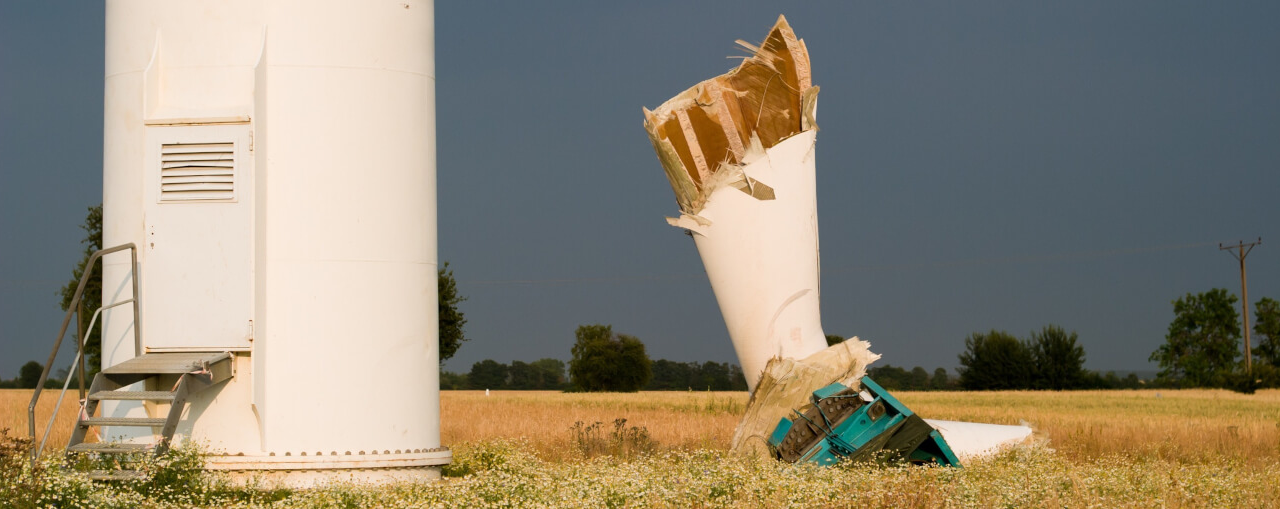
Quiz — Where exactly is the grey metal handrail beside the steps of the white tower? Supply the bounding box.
[27,242,142,463]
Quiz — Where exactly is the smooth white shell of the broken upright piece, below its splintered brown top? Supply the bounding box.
[671,129,827,390]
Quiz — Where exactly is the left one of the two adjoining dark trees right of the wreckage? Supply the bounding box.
[960,330,1036,390]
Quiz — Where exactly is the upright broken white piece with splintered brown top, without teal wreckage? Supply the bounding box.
[645,17,827,389]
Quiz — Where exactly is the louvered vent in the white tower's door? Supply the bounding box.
[160,143,236,202]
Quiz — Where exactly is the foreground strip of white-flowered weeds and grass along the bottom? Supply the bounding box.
[12,432,1280,509]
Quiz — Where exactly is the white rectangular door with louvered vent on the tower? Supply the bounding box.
[140,124,253,352]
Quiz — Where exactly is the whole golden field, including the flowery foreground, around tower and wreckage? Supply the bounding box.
[0,390,1280,508]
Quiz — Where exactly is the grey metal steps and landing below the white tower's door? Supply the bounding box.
[67,352,234,481]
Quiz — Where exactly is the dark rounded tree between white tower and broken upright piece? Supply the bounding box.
[568,325,653,393]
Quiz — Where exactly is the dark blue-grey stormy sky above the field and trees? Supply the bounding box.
[0,1,1280,377]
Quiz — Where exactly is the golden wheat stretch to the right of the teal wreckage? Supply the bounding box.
[896,389,1280,463]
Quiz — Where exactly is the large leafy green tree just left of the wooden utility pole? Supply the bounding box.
[1151,288,1240,388]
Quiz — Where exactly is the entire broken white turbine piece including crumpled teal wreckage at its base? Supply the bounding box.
[644,17,1030,464]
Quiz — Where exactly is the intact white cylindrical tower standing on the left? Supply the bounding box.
[96,0,448,483]
